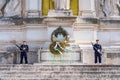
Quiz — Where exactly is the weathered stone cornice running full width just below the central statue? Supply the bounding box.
[0,16,120,27]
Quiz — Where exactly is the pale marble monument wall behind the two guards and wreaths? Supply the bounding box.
[0,0,120,64]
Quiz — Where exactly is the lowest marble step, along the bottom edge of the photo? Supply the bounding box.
[1,75,120,80]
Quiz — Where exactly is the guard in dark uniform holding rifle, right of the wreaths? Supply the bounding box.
[93,40,102,63]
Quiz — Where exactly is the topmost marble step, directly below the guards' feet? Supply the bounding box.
[0,64,120,71]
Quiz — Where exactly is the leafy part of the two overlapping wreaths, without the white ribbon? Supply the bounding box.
[50,26,69,55]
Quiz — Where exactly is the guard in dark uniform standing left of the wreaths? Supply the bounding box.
[20,41,29,64]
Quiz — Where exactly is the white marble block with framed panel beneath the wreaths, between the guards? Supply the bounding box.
[37,42,82,63]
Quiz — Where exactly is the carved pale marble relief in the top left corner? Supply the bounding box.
[0,0,21,17]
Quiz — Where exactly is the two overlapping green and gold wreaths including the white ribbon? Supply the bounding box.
[50,26,69,55]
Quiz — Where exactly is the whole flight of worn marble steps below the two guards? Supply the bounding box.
[0,64,120,80]
